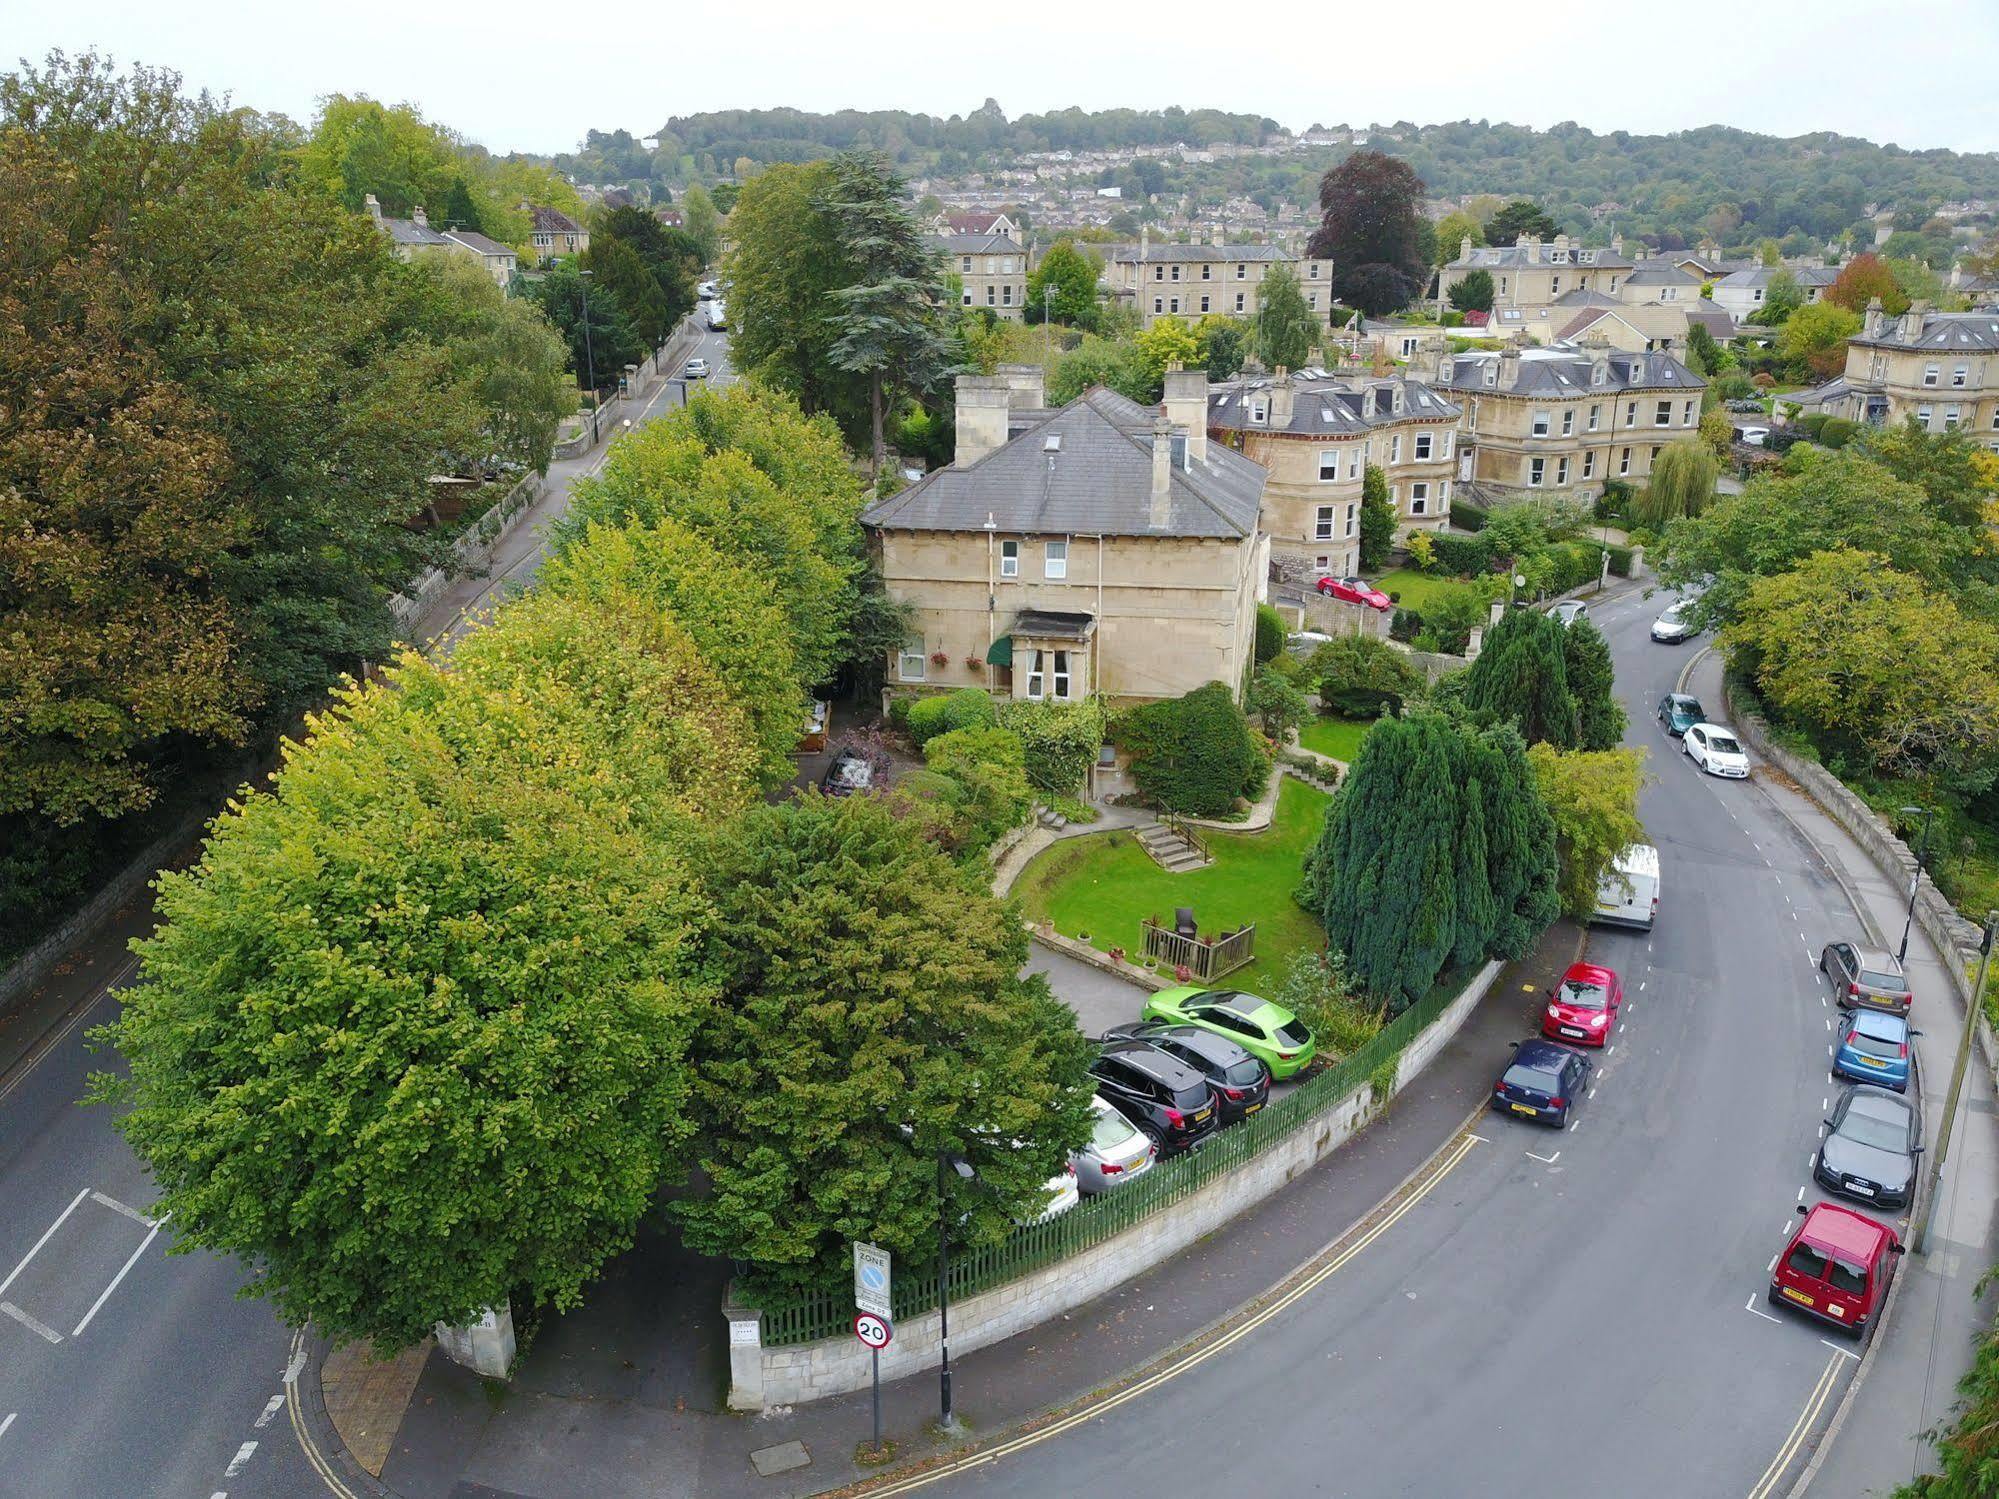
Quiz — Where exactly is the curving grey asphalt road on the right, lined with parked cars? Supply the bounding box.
[936,598,1951,1499]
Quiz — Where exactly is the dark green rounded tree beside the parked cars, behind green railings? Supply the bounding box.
[672,791,1091,1287]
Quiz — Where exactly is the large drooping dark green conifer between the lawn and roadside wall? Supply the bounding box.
[1299,712,1559,1011]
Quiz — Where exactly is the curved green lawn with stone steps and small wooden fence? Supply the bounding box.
[1013,775,1331,993]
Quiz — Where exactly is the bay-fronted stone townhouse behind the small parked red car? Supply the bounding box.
[1191,370,1459,580]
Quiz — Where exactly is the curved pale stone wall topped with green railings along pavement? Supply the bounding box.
[722,963,1499,1411]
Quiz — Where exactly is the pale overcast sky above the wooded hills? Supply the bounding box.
[11,0,1999,154]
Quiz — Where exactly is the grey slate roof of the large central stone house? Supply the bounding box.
[862,386,1263,540]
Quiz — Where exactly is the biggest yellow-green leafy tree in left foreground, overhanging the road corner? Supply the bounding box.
[98,616,728,1349]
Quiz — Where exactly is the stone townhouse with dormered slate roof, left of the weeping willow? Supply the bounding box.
[1435,340,1707,500]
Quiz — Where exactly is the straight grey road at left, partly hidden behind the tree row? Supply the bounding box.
[0,330,732,1499]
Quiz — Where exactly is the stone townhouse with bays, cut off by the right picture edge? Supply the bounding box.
[1797,298,1999,448]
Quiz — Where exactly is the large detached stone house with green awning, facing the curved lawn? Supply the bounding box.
[862,370,1269,702]
